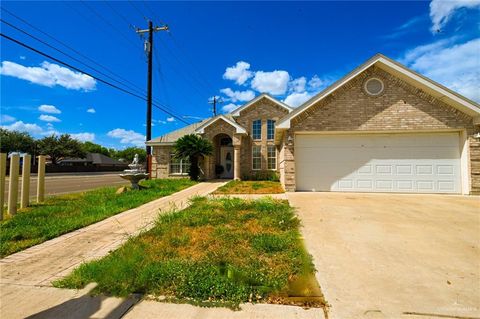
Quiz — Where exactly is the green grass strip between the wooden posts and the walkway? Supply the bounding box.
[0,179,195,257]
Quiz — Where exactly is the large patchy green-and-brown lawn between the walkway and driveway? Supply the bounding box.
[54,197,324,308]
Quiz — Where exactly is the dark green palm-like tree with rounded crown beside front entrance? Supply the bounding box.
[174,134,213,181]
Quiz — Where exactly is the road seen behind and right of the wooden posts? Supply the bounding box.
[5,172,128,201]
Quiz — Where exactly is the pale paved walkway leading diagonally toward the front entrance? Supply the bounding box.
[0,181,225,319]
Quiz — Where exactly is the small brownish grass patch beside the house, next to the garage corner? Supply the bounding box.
[214,181,285,194]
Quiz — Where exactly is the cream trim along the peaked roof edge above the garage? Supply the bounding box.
[276,54,480,129]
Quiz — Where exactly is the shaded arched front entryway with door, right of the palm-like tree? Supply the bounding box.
[213,133,234,178]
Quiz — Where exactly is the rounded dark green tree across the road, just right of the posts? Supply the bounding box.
[38,134,86,164]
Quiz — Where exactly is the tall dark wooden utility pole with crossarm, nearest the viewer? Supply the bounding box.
[136,21,168,173]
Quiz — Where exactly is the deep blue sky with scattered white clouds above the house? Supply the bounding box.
[0,0,480,149]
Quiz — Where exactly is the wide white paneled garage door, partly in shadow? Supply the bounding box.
[295,133,461,193]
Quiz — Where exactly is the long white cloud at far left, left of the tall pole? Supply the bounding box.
[0,61,97,91]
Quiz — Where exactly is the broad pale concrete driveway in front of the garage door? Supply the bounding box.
[287,193,480,319]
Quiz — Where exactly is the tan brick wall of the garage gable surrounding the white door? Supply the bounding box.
[283,67,480,191]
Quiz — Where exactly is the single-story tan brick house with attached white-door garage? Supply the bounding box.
[147,54,480,194]
